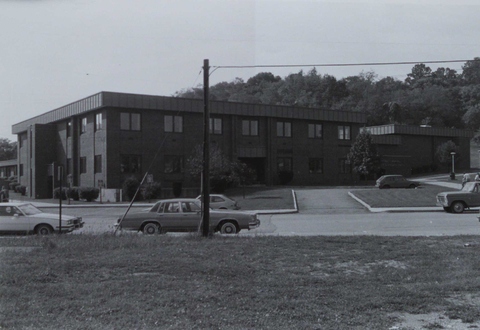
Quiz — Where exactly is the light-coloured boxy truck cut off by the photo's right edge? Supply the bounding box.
[437,181,480,213]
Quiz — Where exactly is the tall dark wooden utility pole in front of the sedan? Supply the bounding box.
[202,59,210,237]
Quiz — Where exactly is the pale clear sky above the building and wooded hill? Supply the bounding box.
[0,0,480,141]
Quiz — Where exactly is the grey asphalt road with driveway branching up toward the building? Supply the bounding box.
[54,189,480,236]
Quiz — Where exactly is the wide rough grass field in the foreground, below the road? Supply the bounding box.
[0,235,480,329]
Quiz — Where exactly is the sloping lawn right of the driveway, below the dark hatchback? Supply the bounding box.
[351,185,456,207]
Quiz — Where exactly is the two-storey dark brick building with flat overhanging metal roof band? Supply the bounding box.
[12,92,365,198]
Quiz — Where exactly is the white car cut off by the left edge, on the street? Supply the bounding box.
[0,202,84,235]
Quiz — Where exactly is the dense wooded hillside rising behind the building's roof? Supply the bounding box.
[175,57,480,135]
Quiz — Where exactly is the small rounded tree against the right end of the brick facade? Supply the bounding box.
[347,129,380,178]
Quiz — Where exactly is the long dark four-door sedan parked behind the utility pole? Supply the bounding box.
[115,198,260,235]
